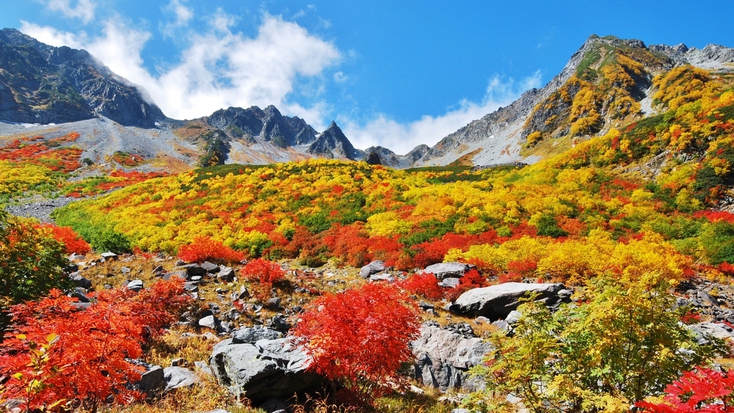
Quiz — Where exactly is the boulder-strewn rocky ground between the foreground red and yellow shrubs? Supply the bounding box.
[57,251,734,412]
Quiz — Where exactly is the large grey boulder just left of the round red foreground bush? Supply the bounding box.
[209,329,323,404]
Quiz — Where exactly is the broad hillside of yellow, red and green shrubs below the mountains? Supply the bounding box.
[56,67,734,281]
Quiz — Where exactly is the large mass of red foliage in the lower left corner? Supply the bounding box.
[0,278,190,411]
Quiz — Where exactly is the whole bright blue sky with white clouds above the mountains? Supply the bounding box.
[0,0,734,153]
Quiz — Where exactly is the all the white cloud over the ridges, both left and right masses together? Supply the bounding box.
[21,14,540,154]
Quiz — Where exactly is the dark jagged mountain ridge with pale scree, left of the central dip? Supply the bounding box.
[0,29,361,171]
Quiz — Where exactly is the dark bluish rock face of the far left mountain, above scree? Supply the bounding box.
[0,29,165,127]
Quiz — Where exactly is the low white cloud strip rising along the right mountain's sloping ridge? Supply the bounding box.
[340,72,540,154]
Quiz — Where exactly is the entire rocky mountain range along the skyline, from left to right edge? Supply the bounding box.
[0,29,734,171]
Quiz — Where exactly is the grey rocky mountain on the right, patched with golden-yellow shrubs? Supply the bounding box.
[416,36,734,166]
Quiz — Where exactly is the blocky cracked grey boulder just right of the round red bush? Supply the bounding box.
[411,323,492,391]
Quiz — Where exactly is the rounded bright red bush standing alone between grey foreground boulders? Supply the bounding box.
[293,283,419,396]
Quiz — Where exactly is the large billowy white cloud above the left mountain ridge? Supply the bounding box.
[21,11,341,122]
